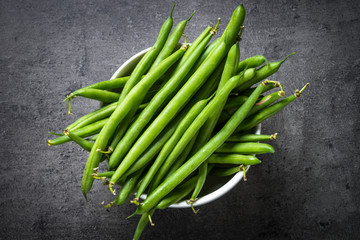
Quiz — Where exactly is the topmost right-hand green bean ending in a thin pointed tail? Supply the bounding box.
[235,53,294,92]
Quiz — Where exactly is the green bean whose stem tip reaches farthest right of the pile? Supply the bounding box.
[235,83,309,132]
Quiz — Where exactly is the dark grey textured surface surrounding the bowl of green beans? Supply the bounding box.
[0,0,360,239]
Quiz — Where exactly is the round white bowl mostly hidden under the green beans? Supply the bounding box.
[111,48,261,208]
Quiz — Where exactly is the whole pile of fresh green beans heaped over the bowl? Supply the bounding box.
[48,4,308,239]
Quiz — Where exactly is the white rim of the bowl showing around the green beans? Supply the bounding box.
[111,47,261,208]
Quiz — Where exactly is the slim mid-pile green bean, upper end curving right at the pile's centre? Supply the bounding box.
[136,99,210,198]
